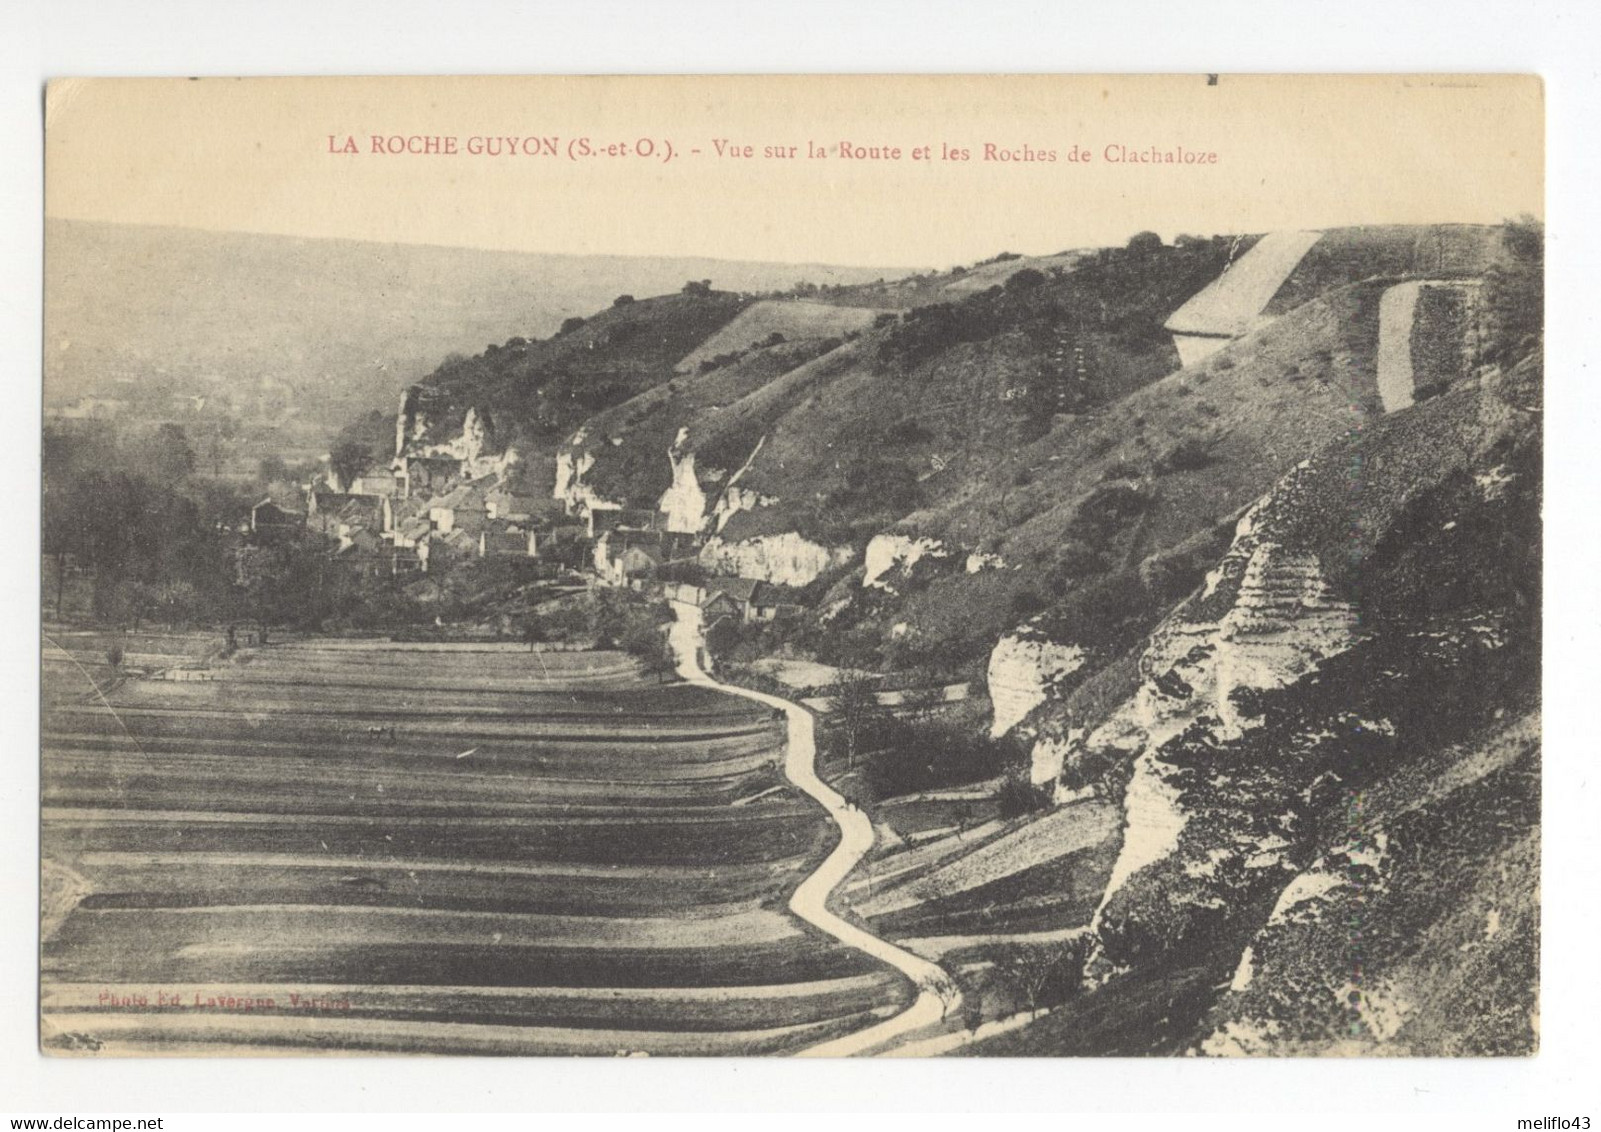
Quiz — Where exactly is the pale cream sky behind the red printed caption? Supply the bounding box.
[45,75,1543,267]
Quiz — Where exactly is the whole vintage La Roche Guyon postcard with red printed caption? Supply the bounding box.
[24,74,1547,1058]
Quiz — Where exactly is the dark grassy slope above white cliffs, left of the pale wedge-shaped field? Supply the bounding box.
[717,245,1248,544]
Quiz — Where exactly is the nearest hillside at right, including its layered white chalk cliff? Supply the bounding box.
[967,342,1542,1057]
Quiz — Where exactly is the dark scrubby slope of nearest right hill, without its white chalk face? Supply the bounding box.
[983,349,1540,1055]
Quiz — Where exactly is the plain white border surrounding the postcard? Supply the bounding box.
[0,0,1601,1130]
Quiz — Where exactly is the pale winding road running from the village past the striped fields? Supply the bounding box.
[668,602,962,1057]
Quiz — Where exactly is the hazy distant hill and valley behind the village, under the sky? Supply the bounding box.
[45,219,898,426]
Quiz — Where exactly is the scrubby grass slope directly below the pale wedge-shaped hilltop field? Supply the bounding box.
[832,285,1382,678]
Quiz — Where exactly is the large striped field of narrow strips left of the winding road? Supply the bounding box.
[42,640,911,1054]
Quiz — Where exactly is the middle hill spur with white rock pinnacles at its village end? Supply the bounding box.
[557,233,1228,549]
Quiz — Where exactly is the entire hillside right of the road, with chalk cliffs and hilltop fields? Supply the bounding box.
[300,223,1543,1055]
